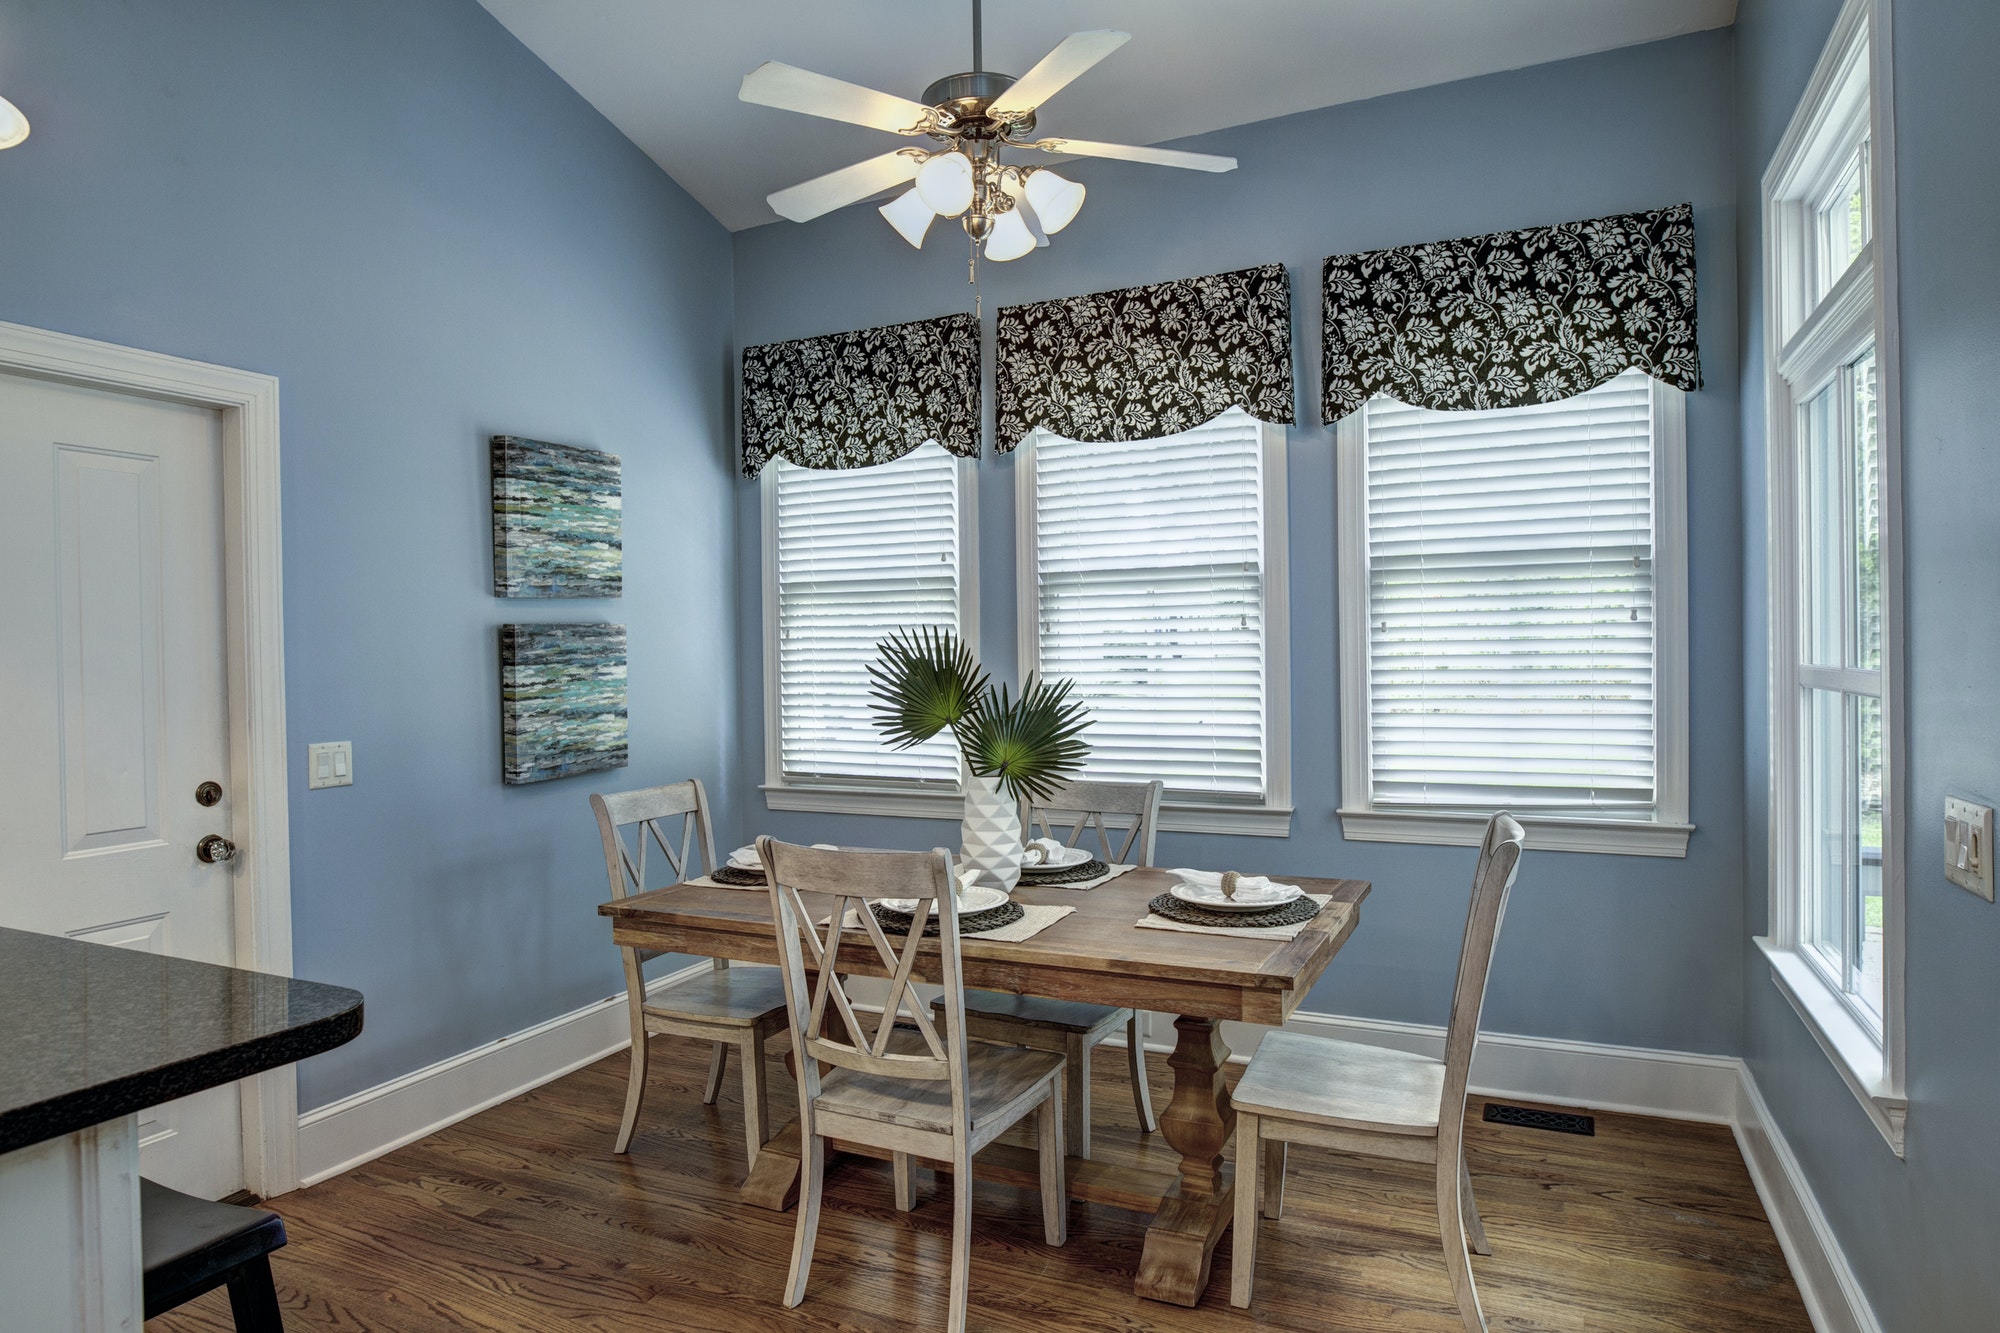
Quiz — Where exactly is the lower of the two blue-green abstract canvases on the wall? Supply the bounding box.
[500,624,626,785]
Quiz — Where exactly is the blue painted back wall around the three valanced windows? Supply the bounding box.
[734,32,1744,1051]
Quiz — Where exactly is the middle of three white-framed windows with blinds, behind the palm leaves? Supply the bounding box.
[1016,408,1292,837]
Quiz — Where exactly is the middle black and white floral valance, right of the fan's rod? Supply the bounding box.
[994,264,1292,452]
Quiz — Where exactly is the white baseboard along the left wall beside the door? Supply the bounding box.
[298,959,712,1185]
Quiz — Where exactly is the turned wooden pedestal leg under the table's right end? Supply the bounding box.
[1132,1015,1236,1305]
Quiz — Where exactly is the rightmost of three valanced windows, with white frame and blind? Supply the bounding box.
[1338,370,1692,857]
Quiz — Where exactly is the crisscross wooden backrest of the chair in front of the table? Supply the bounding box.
[756,837,966,1125]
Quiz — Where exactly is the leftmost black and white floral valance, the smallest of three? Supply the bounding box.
[742,314,980,476]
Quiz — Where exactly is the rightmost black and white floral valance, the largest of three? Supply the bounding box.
[1320,204,1702,422]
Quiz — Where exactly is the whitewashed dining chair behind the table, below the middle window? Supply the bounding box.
[940,781,1162,1157]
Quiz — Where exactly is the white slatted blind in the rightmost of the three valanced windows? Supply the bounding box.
[1364,370,1658,819]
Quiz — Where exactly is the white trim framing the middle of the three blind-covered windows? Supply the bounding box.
[1014,420,1292,839]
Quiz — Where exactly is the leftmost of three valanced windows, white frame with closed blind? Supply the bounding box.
[762,442,980,815]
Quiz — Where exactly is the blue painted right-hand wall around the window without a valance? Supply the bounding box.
[1736,0,2000,1333]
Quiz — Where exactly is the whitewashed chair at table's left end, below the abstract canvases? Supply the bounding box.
[590,779,784,1167]
